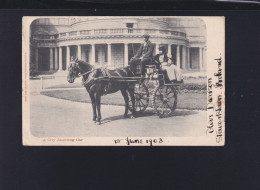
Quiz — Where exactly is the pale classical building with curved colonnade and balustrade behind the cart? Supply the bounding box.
[30,17,206,72]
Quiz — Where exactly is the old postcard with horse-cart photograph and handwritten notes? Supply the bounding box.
[22,16,225,146]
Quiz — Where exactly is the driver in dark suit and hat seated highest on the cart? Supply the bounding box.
[129,34,153,76]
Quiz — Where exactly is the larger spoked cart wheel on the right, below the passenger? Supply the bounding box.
[153,86,177,118]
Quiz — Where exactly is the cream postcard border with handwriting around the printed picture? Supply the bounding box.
[22,16,225,146]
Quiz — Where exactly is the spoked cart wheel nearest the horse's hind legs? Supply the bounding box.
[129,83,149,114]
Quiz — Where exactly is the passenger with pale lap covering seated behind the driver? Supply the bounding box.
[154,46,183,82]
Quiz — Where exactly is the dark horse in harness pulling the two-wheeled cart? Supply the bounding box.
[67,58,136,125]
